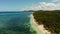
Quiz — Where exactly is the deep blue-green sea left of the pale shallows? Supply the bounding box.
[0,12,35,34]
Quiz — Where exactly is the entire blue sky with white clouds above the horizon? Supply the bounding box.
[0,0,60,11]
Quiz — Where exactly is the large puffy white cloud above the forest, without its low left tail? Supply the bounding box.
[40,2,57,10]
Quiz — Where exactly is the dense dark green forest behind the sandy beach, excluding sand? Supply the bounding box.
[33,10,60,34]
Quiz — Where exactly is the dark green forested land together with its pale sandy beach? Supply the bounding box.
[32,10,60,34]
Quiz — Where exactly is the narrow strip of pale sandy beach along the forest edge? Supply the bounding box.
[31,15,51,34]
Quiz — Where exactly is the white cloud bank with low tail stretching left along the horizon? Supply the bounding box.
[23,2,60,10]
